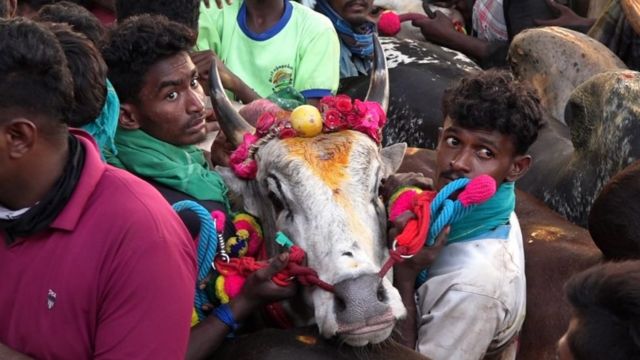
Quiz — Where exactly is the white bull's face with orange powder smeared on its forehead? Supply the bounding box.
[222,131,406,346]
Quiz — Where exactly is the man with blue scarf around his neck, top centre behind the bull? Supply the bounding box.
[315,0,376,78]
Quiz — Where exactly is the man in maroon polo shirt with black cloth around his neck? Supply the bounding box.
[0,19,195,359]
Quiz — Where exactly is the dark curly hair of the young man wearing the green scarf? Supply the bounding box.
[102,15,196,103]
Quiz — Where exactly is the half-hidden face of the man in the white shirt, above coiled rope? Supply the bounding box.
[436,117,530,190]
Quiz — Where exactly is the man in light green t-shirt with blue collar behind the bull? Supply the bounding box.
[197,0,340,102]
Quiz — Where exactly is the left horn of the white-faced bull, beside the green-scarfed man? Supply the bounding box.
[209,61,255,146]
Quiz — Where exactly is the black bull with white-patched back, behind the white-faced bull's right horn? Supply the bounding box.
[340,38,480,148]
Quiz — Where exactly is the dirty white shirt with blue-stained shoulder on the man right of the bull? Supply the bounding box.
[416,213,526,360]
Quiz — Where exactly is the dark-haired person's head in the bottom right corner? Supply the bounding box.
[557,261,640,360]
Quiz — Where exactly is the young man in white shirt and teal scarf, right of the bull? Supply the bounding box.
[394,71,542,360]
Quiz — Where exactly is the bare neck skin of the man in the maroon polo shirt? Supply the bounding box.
[0,137,69,210]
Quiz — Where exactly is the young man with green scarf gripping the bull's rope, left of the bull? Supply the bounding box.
[103,15,295,359]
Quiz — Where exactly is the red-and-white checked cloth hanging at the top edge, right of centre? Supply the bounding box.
[471,0,509,41]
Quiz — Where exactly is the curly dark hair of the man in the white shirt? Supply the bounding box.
[442,70,543,155]
